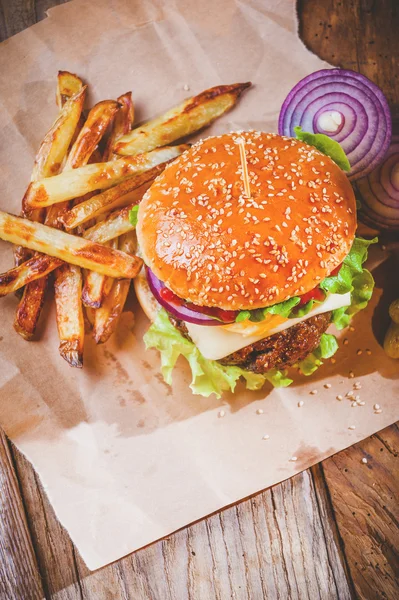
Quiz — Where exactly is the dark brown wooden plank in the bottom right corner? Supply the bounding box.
[323,425,399,600]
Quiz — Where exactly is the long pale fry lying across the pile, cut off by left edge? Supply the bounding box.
[0,211,142,279]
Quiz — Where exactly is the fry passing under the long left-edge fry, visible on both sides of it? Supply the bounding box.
[0,205,139,296]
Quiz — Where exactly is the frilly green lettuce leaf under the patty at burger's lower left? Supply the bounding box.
[144,309,292,398]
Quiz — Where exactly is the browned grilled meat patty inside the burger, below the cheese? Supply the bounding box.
[169,312,331,373]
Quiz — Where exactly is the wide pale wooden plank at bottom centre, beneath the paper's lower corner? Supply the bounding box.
[12,452,351,600]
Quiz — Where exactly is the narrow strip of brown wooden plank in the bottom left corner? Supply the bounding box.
[0,430,44,600]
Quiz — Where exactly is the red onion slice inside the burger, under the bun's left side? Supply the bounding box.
[146,268,237,326]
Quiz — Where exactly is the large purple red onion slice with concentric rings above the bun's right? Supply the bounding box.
[278,69,391,180]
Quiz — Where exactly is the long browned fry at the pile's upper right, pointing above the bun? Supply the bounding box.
[115,83,251,156]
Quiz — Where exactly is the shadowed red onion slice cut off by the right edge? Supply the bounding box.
[356,135,399,231]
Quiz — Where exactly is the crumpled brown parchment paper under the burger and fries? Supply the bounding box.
[0,0,399,569]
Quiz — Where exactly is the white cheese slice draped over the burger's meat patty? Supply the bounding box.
[186,292,351,360]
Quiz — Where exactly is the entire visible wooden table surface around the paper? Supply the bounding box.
[0,0,399,600]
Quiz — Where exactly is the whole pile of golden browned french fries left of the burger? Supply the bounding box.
[0,71,250,367]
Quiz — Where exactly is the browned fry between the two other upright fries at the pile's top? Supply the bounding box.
[63,100,119,172]
